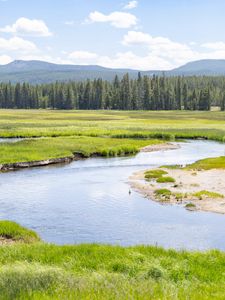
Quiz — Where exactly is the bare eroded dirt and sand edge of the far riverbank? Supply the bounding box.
[0,143,176,172]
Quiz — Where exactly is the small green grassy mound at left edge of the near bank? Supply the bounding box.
[0,221,40,243]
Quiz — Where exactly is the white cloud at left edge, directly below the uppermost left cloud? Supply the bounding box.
[0,37,37,52]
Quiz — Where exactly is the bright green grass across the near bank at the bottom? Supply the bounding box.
[0,222,225,300]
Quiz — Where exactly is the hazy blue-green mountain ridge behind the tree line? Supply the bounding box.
[0,60,225,84]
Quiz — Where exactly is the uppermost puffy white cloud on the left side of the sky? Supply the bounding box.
[0,18,52,37]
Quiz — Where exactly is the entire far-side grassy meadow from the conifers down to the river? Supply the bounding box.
[0,110,225,163]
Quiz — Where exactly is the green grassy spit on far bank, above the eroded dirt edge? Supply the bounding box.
[0,136,162,164]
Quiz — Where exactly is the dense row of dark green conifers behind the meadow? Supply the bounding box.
[0,73,225,111]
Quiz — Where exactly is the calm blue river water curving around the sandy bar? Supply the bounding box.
[0,141,225,250]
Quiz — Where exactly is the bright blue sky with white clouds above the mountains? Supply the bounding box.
[0,0,225,70]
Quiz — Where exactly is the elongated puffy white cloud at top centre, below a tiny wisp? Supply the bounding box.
[86,11,137,28]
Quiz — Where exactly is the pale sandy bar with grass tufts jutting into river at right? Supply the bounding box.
[129,169,225,214]
